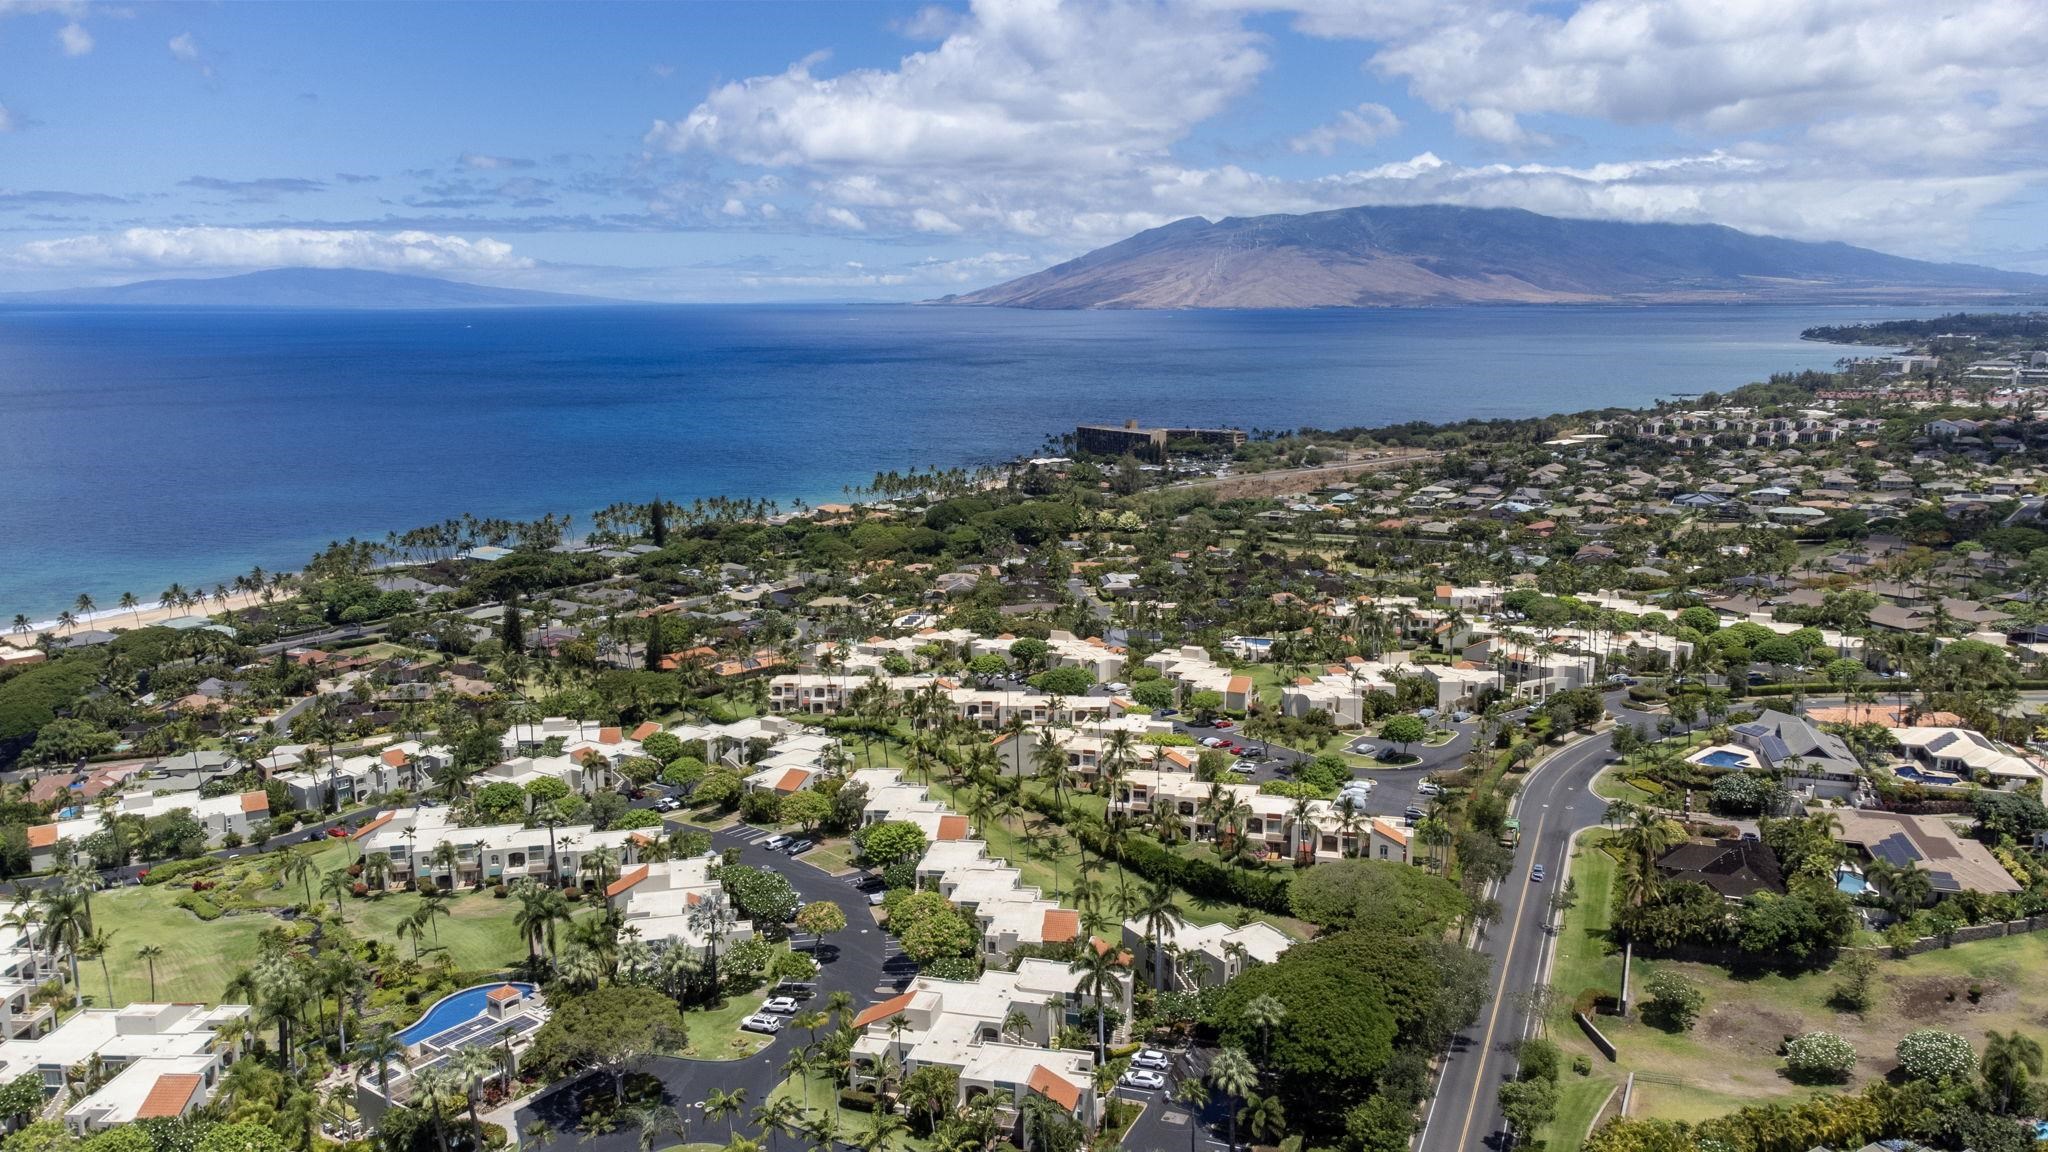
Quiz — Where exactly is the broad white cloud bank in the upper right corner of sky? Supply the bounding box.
[1348,0,2048,160]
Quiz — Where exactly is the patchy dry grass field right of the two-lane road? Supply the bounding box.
[1548,834,2048,1148]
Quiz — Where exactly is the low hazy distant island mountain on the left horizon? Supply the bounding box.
[0,269,621,310]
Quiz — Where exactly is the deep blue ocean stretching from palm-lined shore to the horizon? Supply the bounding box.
[0,305,1942,617]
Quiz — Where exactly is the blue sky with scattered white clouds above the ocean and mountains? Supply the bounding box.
[0,0,2048,301]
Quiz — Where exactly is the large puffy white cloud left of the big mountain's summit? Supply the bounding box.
[647,0,1266,174]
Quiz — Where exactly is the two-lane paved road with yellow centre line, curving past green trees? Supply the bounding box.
[1415,693,1655,1152]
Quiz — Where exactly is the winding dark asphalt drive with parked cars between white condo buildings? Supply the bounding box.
[518,826,901,1152]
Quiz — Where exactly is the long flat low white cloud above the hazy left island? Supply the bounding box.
[16,228,532,273]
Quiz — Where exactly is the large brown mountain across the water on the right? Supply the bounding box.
[936,205,2048,307]
